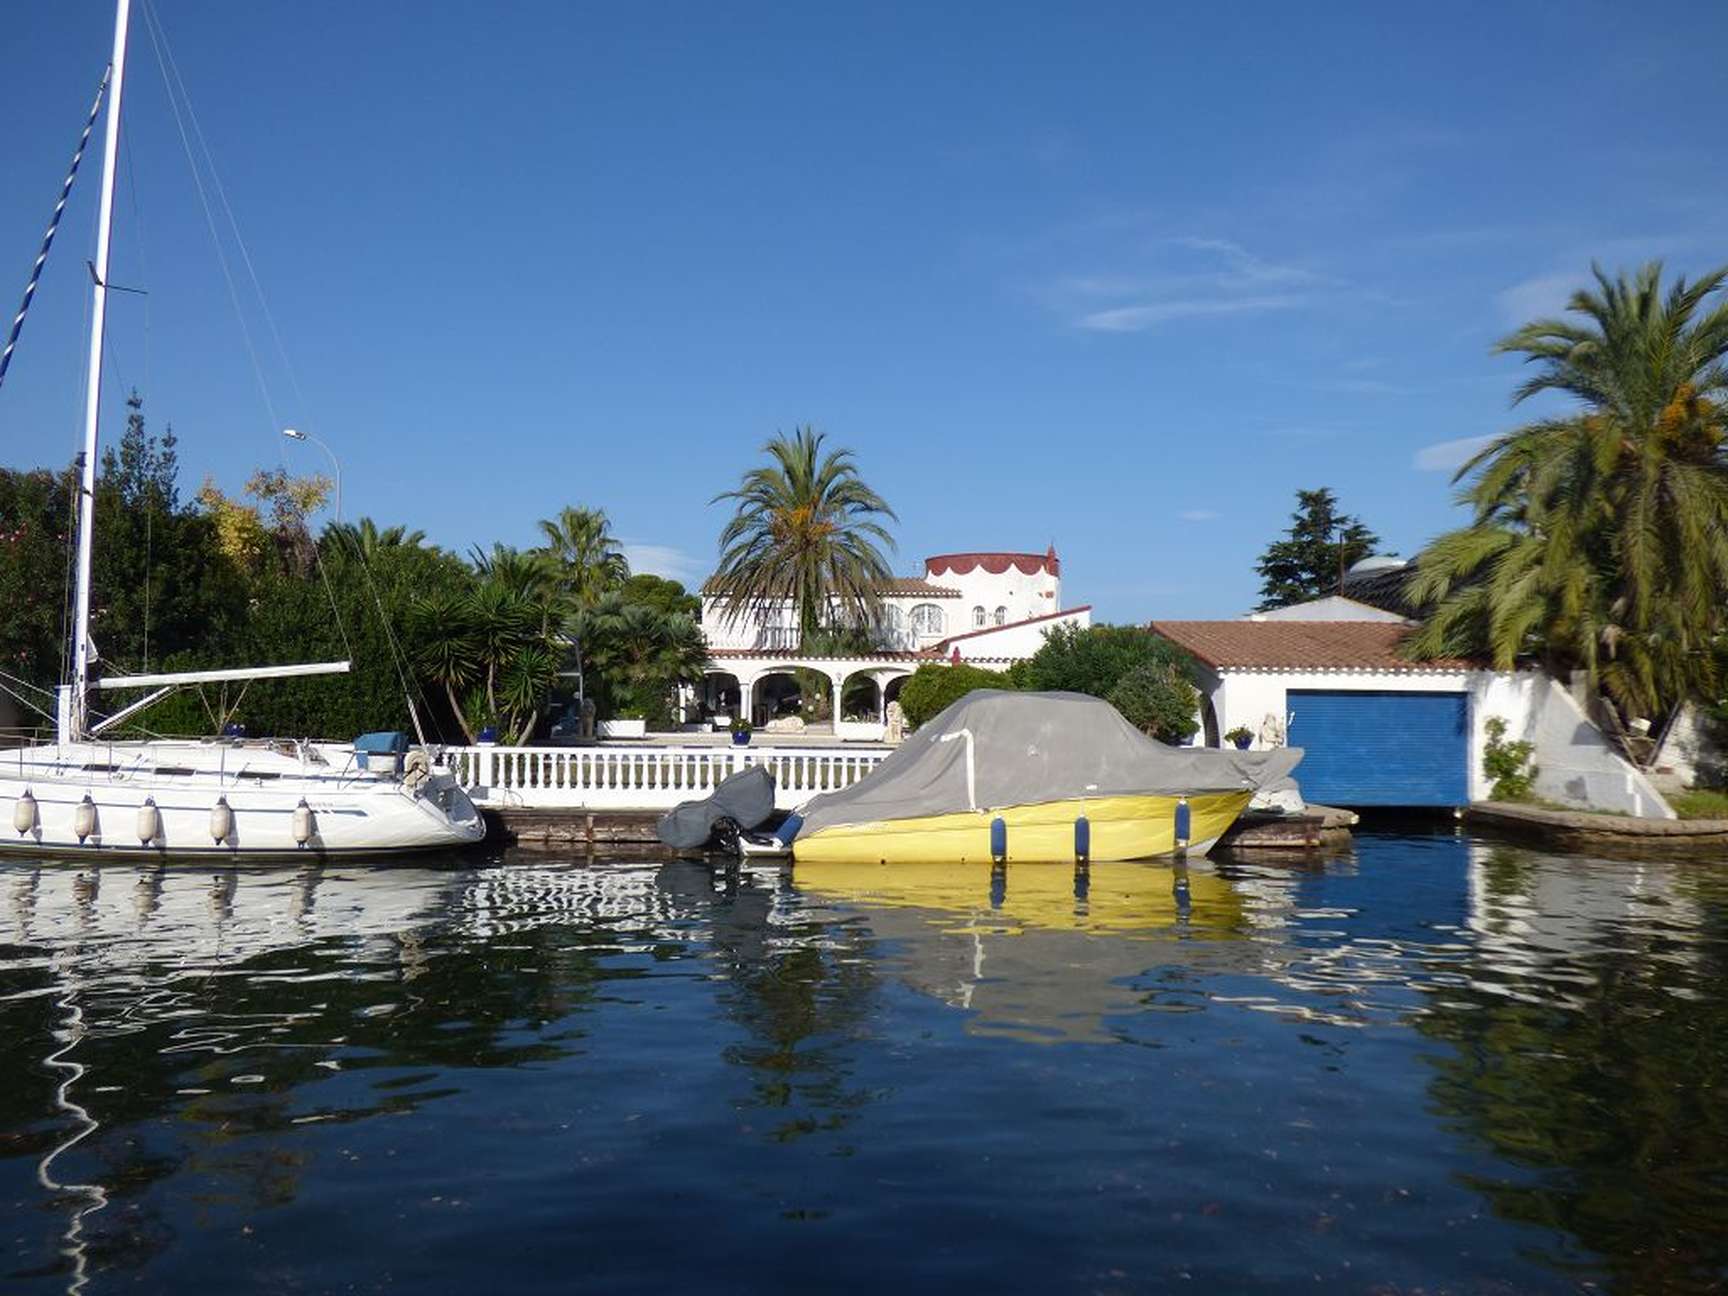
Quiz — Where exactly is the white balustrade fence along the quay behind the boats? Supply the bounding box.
[435,743,888,810]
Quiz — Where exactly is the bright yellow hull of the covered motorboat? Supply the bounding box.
[791,791,1253,864]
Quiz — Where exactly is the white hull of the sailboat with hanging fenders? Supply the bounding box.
[0,741,486,861]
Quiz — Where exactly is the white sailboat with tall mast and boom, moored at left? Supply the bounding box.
[0,0,486,861]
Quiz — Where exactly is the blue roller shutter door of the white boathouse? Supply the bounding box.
[1287,689,1471,805]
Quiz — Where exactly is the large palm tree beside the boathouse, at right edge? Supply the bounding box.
[1410,263,1728,717]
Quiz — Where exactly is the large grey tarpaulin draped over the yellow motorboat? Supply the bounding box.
[800,689,1301,836]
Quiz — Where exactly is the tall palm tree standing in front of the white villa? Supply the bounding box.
[708,427,899,646]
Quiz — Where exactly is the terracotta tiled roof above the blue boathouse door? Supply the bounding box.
[1151,620,1481,670]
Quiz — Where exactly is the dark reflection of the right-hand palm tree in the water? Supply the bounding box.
[1415,850,1728,1293]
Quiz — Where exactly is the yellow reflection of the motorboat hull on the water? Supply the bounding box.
[791,859,1242,938]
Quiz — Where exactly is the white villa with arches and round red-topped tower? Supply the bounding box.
[696,546,1092,741]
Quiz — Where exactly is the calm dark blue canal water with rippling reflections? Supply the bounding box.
[0,835,1728,1293]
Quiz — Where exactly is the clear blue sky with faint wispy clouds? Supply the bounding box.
[0,0,1728,620]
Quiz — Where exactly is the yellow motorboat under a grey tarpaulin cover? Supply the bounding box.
[791,689,1301,864]
